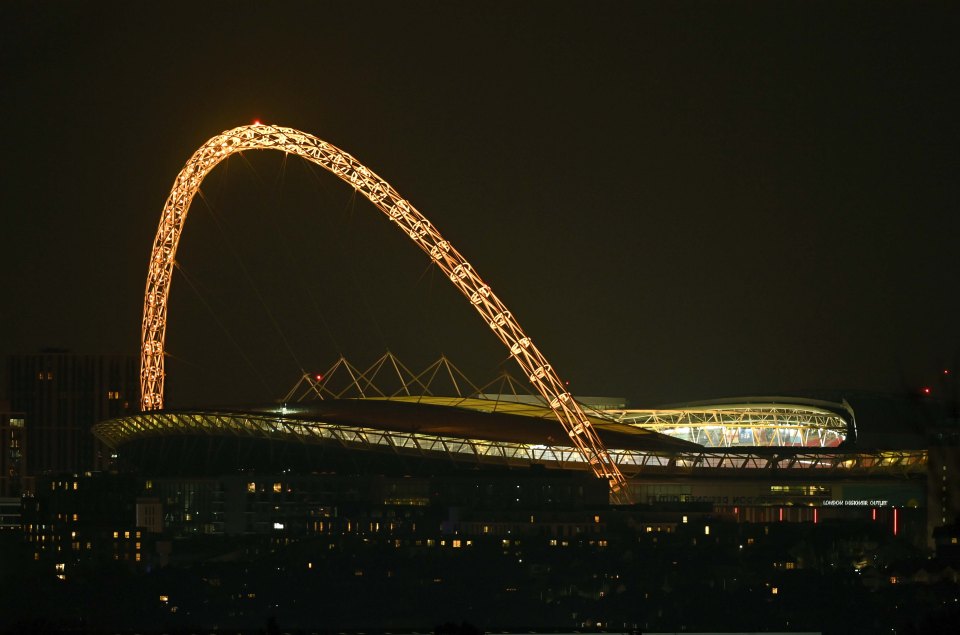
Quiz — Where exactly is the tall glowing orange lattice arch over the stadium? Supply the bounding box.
[140,124,626,496]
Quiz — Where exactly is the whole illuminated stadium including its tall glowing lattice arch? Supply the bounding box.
[84,122,960,540]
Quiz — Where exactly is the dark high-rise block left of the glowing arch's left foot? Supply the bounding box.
[7,350,139,476]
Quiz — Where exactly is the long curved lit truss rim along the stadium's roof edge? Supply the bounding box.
[94,397,926,475]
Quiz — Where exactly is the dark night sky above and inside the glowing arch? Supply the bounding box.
[0,0,960,405]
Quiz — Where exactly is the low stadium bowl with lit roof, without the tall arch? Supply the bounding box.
[94,356,944,542]
